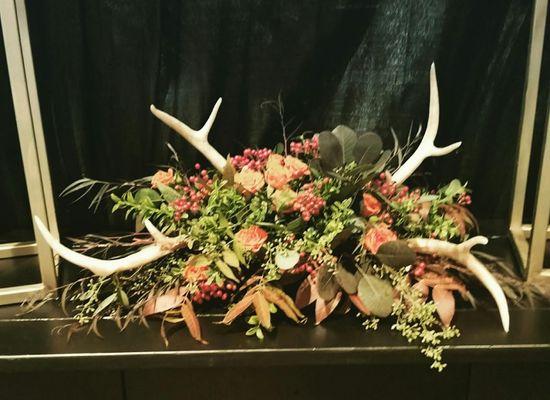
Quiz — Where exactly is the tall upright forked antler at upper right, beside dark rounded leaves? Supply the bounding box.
[392,64,462,184]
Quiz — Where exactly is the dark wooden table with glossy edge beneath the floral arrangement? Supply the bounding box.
[0,236,550,400]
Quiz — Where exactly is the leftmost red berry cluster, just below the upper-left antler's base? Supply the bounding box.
[172,164,213,221]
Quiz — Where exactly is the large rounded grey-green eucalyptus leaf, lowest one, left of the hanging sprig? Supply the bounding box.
[357,274,393,318]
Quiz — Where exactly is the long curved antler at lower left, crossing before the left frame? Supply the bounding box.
[34,215,185,276]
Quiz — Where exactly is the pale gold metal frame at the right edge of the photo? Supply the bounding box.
[510,0,550,280]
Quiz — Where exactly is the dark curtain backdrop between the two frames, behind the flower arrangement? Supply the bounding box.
[23,0,531,238]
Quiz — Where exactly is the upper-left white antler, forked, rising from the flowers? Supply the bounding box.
[151,97,227,172]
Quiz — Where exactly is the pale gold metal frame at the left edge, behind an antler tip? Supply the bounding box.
[0,0,58,304]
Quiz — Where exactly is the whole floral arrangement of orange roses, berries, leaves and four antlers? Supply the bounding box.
[36,66,509,370]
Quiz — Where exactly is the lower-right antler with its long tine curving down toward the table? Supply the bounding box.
[408,236,510,332]
